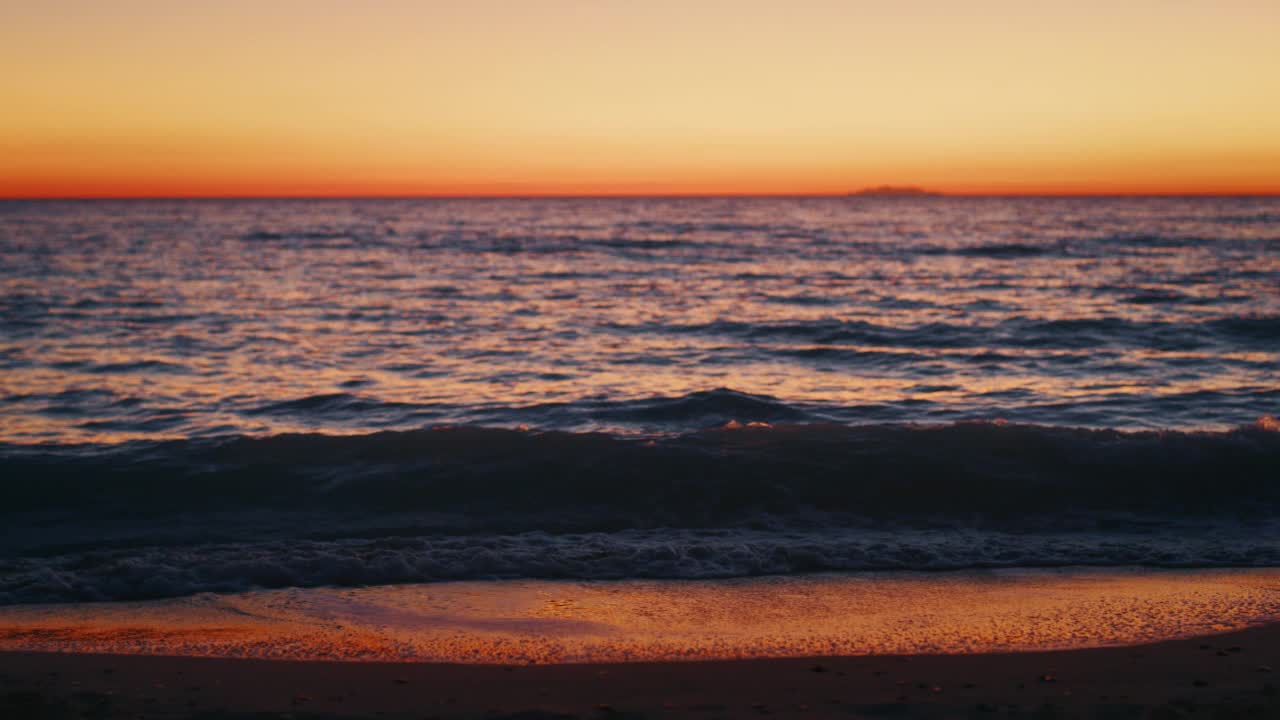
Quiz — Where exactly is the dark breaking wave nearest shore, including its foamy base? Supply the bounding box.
[0,417,1280,602]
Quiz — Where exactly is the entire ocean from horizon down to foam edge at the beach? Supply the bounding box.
[0,197,1280,605]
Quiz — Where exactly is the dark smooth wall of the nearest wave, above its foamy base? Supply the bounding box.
[0,415,1280,527]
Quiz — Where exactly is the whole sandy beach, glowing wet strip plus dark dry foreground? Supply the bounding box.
[0,569,1280,720]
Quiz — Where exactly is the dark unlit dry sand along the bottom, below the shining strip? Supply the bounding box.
[0,624,1280,720]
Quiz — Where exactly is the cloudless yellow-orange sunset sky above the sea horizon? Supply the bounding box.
[0,0,1280,197]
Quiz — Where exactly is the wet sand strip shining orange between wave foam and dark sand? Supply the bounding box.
[0,569,1280,664]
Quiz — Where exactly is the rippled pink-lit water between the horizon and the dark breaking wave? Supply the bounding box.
[0,199,1280,442]
